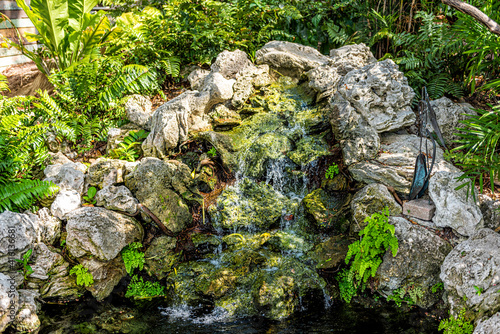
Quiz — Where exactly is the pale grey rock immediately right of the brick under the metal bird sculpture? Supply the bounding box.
[429,172,484,236]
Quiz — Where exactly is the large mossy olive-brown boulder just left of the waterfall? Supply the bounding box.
[125,158,201,233]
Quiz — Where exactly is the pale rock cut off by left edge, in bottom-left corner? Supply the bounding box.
[0,274,19,332]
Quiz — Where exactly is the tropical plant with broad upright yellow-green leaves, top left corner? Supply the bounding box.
[0,0,110,76]
